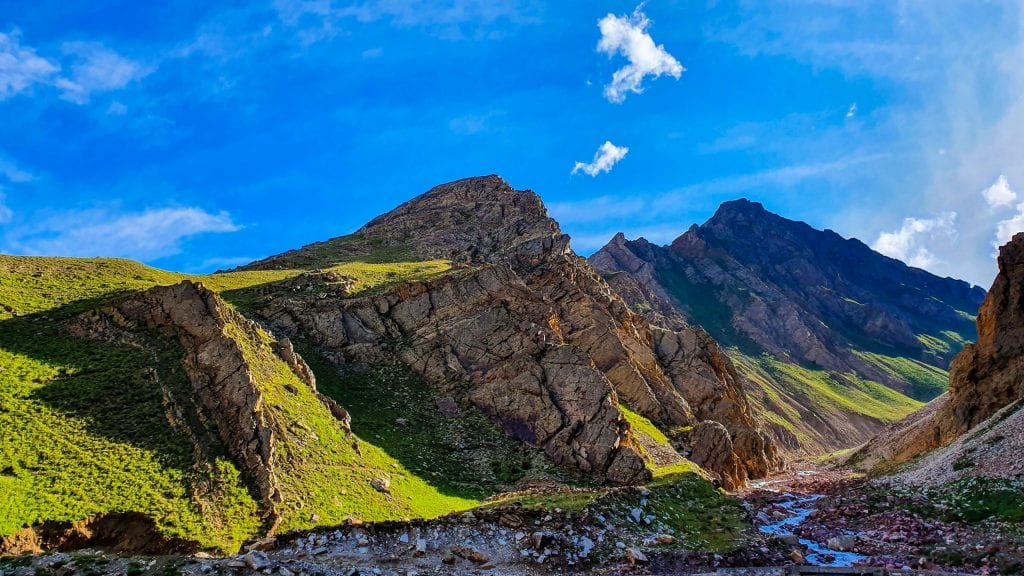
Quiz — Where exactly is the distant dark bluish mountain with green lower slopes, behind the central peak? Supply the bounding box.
[590,200,984,453]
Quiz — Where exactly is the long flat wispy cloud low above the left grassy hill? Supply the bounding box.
[8,208,241,260]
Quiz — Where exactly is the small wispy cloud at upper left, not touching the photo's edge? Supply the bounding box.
[54,42,148,104]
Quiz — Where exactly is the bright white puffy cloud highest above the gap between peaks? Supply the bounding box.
[597,6,685,104]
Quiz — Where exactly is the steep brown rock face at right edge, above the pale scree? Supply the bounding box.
[850,234,1024,478]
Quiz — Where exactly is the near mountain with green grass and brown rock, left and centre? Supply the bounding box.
[0,176,782,554]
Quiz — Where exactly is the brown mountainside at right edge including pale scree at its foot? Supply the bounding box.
[850,234,1024,477]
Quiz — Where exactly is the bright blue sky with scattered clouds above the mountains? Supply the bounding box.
[0,0,1024,286]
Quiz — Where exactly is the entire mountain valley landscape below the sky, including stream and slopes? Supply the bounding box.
[0,176,1024,576]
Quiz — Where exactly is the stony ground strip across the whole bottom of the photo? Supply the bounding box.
[0,463,1024,576]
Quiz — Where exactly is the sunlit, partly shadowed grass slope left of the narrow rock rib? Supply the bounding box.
[0,317,260,549]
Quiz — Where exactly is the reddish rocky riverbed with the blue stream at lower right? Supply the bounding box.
[745,470,1024,574]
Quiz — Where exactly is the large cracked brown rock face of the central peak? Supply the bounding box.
[254,176,781,485]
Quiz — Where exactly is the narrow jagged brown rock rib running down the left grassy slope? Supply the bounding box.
[71,281,331,531]
